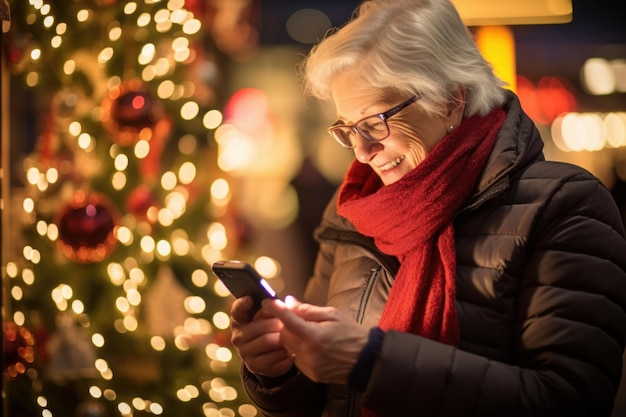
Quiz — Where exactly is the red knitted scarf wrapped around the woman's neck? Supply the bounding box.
[337,109,504,352]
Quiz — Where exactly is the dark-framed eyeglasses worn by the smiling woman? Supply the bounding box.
[328,95,420,149]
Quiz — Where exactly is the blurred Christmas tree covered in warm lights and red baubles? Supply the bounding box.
[3,0,270,417]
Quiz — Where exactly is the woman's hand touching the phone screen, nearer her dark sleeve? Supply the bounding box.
[263,297,369,384]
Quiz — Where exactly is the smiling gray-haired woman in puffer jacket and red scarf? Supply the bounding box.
[231,0,626,417]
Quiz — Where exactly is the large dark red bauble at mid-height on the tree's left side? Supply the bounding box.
[56,190,118,263]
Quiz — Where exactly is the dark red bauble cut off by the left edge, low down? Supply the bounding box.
[2,321,35,378]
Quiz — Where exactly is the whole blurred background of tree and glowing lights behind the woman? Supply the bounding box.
[0,0,626,417]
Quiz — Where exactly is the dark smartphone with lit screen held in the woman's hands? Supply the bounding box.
[211,261,276,311]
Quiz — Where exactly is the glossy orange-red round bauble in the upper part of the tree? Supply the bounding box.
[102,80,163,146]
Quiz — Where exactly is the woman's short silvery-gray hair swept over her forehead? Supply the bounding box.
[300,0,505,117]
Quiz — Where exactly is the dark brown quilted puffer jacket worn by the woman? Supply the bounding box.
[244,94,626,417]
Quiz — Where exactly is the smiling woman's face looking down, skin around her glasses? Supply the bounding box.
[332,72,460,185]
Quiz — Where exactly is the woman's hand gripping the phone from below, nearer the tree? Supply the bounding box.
[230,296,293,377]
